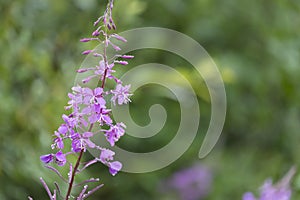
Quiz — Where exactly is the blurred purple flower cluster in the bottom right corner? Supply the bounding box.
[243,168,295,200]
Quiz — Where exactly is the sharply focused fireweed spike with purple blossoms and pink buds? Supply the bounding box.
[28,0,133,200]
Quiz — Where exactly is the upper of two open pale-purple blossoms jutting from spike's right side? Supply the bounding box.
[111,84,132,105]
